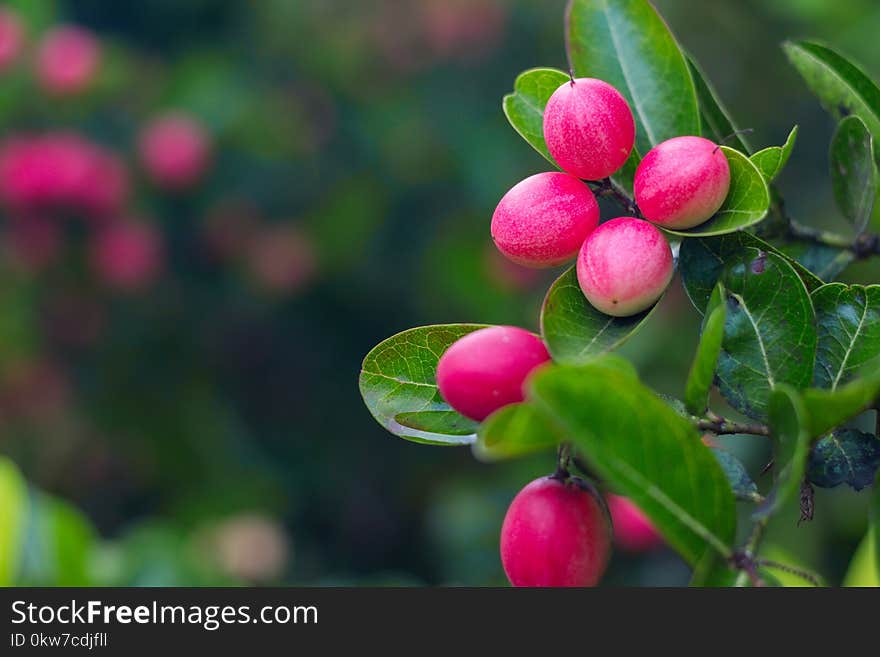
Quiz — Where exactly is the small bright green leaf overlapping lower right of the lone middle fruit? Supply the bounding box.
[474,403,565,461]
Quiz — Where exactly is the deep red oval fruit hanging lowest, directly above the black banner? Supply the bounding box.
[501,477,611,586]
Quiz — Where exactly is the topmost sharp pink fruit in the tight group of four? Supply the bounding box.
[544,78,636,180]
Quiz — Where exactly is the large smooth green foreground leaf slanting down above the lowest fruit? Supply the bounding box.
[529,357,736,564]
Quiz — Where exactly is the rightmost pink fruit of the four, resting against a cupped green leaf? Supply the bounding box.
[633,137,730,230]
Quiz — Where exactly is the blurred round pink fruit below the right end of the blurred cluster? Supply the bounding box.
[91,221,163,290]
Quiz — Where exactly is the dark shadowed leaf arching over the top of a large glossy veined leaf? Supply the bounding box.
[678,233,823,313]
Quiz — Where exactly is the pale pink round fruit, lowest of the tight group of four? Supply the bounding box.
[577,217,672,317]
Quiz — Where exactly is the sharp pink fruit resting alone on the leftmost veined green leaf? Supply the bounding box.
[437,326,550,421]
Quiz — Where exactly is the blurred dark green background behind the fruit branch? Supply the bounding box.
[0,0,880,585]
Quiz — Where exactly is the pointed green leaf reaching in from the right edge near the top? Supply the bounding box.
[782,41,880,148]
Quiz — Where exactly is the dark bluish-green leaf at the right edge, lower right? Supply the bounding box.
[807,429,880,490]
